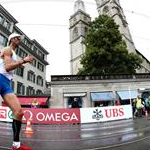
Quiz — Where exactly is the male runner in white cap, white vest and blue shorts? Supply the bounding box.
[0,33,33,150]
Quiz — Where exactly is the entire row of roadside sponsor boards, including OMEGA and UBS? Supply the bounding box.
[0,105,132,124]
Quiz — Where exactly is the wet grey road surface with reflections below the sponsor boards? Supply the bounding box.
[0,118,150,150]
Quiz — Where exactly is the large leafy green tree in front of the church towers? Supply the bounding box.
[78,15,142,75]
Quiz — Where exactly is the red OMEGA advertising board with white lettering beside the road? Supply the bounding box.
[22,108,81,124]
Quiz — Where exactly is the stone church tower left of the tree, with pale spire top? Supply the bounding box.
[69,0,91,75]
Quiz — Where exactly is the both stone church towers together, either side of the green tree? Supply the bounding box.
[69,0,150,75]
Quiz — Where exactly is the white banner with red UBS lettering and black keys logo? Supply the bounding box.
[80,105,132,123]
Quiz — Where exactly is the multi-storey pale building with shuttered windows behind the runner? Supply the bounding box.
[0,5,49,95]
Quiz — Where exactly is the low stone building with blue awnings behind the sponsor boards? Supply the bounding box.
[50,73,150,108]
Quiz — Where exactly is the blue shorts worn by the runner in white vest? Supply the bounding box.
[0,74,14,97]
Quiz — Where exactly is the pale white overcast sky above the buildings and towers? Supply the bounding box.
[0,0,150,81]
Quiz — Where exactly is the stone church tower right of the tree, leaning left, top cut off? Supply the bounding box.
[95,0,150,73]
